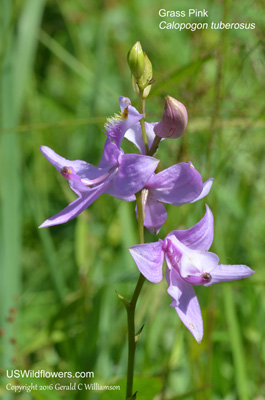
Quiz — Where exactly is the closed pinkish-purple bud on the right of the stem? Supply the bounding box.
[154,96,188,139]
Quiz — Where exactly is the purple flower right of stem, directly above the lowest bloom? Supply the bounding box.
[136,162,213,234]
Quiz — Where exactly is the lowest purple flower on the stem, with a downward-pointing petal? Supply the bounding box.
[129,206,254,343]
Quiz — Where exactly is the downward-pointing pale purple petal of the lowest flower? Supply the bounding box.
[168,269,203,343]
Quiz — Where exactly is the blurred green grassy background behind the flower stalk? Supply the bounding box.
[0,0,265,400]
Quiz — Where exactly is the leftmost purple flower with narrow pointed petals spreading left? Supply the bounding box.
[40,138,159,228]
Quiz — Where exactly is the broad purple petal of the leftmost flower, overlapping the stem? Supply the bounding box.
[113,154,159,196]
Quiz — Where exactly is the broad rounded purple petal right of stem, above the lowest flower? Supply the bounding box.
[147,162,203,205]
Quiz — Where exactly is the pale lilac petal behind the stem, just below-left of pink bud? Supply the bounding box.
[124,122,157,154]
